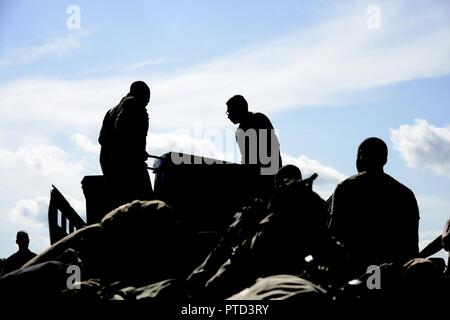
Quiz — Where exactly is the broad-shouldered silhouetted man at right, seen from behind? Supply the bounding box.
[330,138,419,271]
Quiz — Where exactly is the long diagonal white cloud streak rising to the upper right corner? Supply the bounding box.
[150,2,450,119]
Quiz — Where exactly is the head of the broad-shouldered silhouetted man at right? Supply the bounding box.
[356,137,388,172]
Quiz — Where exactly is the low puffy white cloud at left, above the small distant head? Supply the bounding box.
[0,141,92,244]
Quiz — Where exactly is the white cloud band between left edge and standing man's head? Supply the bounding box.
[0,79,125,134]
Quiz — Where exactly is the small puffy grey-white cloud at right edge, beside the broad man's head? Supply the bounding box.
[390,119,450,177]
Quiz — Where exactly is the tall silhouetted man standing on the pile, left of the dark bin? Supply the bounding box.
[98,81,153,208]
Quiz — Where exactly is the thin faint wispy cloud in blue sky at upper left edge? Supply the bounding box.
[0,32,89,69]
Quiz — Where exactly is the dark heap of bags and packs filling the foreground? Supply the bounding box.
[0,198,450,314]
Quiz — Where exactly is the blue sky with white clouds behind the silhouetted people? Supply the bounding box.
[0,0,450,257]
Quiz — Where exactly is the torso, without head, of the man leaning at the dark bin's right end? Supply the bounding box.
[236,112,282,169]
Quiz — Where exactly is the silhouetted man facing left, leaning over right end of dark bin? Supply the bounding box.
[226,95,282,175]
